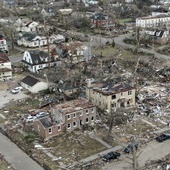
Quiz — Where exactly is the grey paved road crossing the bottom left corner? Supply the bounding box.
[0,133,43,170]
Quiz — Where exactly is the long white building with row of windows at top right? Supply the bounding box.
[136,15,170,28]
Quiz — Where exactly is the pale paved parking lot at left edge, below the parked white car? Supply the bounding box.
[0,90,28,108]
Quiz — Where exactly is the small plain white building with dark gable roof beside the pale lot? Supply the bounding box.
[20,76,48,93]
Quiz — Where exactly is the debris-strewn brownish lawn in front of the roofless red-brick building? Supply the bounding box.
[44,131,106,164]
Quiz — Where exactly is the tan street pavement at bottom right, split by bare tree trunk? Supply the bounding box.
[102,140,170,170]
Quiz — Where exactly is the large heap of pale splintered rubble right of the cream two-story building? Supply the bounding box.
[136,83,170,124]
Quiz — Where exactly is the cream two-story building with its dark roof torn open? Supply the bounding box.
[86,79,136,112]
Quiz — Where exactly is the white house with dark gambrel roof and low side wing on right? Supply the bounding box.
[21,50,61,73]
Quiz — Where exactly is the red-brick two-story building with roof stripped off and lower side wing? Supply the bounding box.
[34,98,96,140]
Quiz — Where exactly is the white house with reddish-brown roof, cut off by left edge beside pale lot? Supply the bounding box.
[0,52,12,80]
